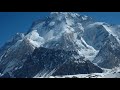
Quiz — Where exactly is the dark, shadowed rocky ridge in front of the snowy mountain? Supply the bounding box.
[12,47,102,78]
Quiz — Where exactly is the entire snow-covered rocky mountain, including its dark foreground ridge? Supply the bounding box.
[0,12,120,78]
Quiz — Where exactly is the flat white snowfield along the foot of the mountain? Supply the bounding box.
[34,68,120,78]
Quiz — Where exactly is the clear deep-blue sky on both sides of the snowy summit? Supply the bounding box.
[0,12,120,46]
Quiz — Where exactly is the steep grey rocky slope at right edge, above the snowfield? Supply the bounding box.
[93,35,120,69]
